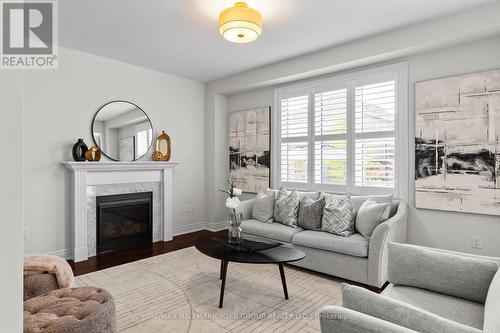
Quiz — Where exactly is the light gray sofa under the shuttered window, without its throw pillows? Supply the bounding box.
[238,190,407,288]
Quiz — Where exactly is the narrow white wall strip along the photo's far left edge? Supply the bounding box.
[0,70,23,332]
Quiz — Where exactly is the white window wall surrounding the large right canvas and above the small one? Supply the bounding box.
[227,37,500,256]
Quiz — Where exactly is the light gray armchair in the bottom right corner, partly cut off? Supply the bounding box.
[320,243,500,333]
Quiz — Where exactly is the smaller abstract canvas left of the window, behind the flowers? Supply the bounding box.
[229,107,271,193]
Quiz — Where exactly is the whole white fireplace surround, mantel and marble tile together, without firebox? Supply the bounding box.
[63,161,177,262]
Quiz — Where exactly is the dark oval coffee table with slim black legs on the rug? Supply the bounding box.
[195,237,305,308]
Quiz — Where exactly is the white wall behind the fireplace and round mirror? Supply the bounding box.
[22,48,206,254]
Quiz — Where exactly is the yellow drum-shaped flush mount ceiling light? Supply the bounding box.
[219,2,262,43]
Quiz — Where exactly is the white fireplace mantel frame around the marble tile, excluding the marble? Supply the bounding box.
[63,161,178,262]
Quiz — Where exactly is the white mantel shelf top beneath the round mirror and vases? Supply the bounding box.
[62,161,179,171]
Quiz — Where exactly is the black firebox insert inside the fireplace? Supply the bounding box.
[96,192,153,253]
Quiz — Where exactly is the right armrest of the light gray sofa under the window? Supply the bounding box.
[368,201,408,288]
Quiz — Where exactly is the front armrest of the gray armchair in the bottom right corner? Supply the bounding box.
[342,283,481,333]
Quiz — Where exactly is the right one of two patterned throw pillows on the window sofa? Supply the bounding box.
[321,195,355,236]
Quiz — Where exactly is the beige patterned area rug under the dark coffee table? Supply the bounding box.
[76,247,340,333]
